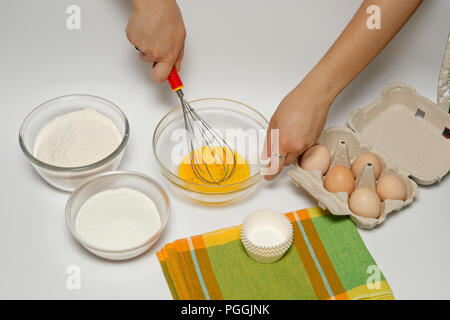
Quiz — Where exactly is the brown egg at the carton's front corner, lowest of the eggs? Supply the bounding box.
[348,187,381,219]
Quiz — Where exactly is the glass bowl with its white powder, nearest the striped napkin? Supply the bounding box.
[66,171,170,260]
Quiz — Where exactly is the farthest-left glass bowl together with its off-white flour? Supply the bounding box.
[19,94,130,191]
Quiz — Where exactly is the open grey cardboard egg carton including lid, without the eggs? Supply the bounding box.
[288,83,450,229]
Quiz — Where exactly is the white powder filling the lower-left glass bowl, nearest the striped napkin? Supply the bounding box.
[76,188,161,250]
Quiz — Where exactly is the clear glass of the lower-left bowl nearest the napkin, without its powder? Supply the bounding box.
[66,171,170,260]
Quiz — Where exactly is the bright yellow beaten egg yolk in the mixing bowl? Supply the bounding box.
[178,147,250,193]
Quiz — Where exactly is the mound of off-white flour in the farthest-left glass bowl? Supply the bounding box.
[33,109,122,167]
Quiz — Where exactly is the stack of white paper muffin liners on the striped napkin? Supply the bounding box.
[241,210,294,263]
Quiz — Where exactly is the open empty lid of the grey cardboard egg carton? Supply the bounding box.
[348,83,450,185]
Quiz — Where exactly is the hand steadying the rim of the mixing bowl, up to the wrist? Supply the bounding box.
[262,79,334,180]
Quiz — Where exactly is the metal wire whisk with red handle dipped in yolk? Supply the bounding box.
[167,67,236,184]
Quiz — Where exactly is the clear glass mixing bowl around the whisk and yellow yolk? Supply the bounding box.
[153,98,269,204]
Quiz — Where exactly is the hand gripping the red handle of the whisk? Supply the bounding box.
[126,0,186,83]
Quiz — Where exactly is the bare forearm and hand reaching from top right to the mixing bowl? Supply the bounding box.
[262,0,423,180]
